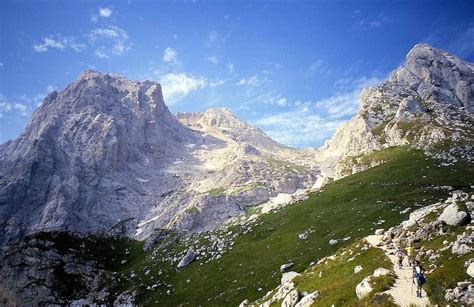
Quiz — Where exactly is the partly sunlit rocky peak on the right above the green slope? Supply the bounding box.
[315,44,474,178]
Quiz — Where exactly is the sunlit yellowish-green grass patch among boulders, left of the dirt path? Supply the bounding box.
[294,241,394,306]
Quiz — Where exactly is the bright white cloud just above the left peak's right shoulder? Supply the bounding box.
[159,73,209,105]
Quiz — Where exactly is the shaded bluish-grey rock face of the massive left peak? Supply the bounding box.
[0,71,192,248]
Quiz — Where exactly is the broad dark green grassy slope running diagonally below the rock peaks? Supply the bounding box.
[109,148,474,305]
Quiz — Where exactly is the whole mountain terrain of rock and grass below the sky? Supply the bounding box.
[0,44,474,306]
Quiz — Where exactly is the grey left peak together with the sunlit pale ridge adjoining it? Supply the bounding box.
[0,70,318,246]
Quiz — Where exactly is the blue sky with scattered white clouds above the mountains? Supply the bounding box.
[0,0,474,147]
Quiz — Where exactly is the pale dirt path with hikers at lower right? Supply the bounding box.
[365,235,430,307]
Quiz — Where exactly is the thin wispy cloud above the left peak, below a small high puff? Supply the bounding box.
[87,26,131,59]
